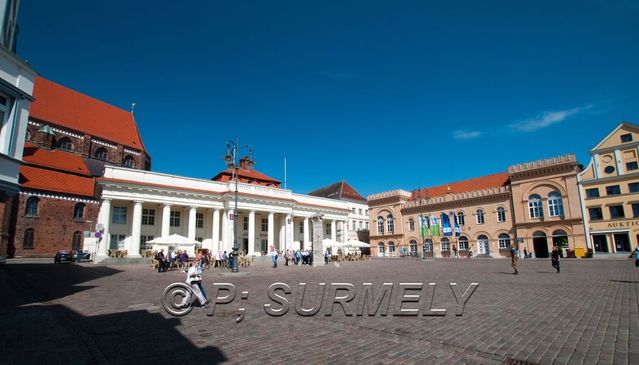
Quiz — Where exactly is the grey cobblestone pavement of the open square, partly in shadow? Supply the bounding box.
[0,259,639,365]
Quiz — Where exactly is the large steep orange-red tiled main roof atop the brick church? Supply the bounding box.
[29,77,144,150]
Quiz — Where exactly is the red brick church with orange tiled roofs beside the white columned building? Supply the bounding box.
[7,78,151,257]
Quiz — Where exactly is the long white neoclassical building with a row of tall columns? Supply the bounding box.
[91,166,351,261]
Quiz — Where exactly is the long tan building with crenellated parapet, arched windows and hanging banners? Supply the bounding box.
[368,155,585,257]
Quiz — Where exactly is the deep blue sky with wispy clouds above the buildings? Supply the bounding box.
[18,0,639,196]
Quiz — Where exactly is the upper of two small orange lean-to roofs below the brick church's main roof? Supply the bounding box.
[22,142,91,176]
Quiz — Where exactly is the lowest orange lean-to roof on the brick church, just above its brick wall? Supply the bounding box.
[19,166,95,197]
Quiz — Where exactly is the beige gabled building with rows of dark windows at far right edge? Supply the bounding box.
[579,122,639,255]
